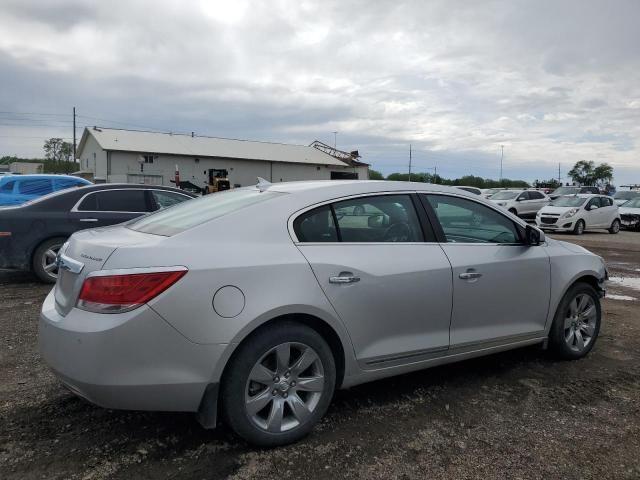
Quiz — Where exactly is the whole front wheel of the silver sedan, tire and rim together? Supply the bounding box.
[549,282,602,360]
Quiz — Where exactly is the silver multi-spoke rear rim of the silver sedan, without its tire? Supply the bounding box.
[245,342,325,433]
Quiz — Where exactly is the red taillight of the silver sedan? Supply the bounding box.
[77,269,187,313]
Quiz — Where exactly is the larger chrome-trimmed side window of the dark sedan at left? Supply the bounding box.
[70,187,152,229]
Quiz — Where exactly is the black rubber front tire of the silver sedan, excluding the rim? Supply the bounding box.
[549,282,602,360]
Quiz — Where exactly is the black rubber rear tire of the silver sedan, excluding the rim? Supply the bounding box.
[220,321,336,448]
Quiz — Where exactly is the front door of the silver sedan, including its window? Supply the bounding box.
[422,194,550,348]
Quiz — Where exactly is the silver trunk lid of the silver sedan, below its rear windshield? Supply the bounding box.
[54,225,164,316]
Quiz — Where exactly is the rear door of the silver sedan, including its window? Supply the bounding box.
[293,193,452,368]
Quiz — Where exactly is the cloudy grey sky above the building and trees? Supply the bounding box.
[0,0,640,184]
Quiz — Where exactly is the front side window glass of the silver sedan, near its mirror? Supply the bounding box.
[427,195,520,244]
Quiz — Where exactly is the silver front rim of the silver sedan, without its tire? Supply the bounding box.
[564,293,598,352]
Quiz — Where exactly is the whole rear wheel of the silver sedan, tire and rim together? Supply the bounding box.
[221,322,336,447]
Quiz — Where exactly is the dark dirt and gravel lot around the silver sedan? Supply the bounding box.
[0,232,640,480]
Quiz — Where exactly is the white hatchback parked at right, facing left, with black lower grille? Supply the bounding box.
[536,194,620,235]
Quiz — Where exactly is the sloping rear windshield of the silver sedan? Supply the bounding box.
[127,188,286,236]
